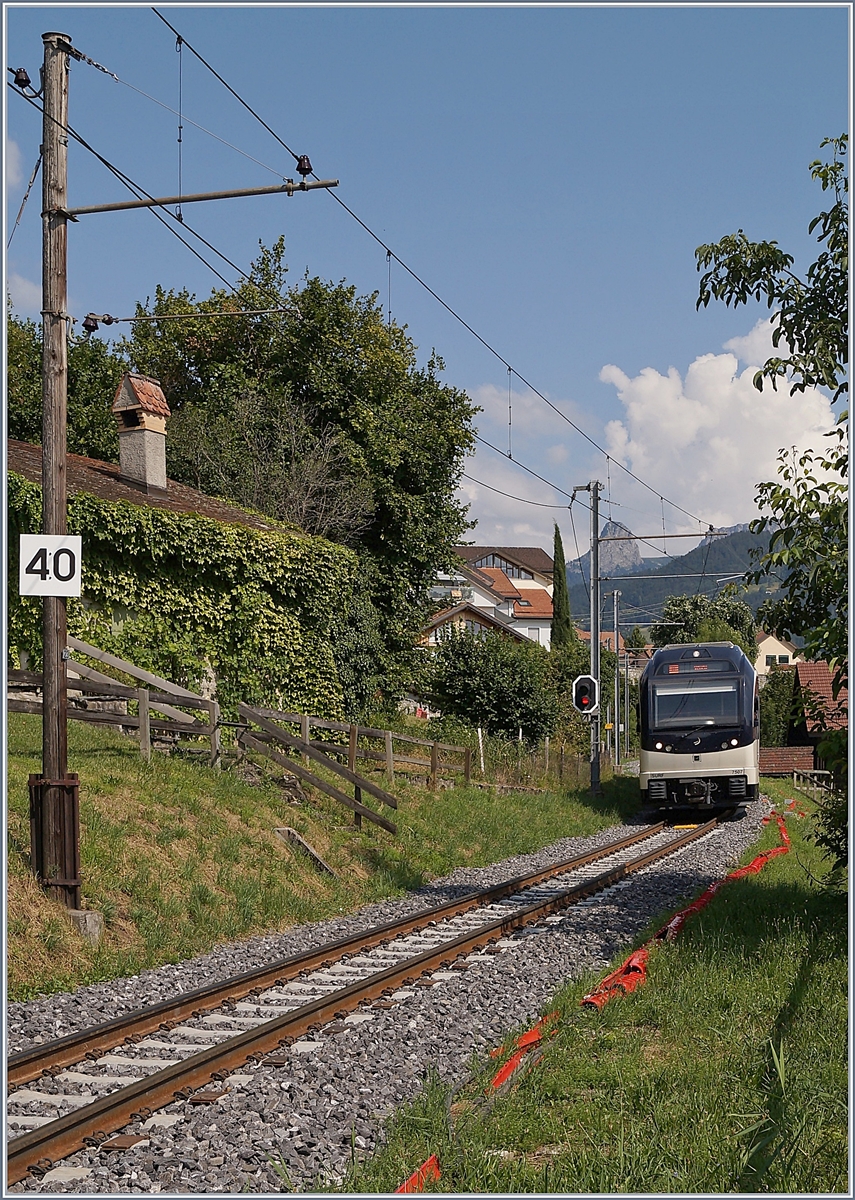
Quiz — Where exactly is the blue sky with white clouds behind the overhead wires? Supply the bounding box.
[5,4,849,548]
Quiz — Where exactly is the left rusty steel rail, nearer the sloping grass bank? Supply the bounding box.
[6,821,665,1087]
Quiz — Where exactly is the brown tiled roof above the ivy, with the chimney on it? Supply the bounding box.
[7,438,287,532]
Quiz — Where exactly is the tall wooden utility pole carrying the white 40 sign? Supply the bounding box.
[30,34,80,908]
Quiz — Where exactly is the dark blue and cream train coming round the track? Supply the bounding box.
[639,642,760,809]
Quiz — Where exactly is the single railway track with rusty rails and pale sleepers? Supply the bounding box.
[7,820,717,1184]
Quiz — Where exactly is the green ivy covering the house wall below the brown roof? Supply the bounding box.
[8,472,358,719]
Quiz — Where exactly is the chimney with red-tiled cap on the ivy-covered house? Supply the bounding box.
[113,373,169,493]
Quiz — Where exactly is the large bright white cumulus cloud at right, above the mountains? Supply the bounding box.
[599,336,835,528]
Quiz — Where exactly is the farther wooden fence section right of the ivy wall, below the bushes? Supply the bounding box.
[253,708,472,791]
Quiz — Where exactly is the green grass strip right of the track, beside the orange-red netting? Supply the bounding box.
[342,781,848,1194]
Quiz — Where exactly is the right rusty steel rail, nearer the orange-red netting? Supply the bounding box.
[6,818,718,1186]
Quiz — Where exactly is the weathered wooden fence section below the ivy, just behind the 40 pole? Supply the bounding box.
[7,637,221,767]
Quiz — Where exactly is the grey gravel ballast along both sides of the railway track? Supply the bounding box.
[7,802,769,1194]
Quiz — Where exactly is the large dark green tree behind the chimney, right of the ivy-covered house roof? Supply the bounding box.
[117,239,476,691]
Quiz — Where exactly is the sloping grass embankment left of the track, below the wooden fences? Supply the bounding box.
[7,714,638,1000]
